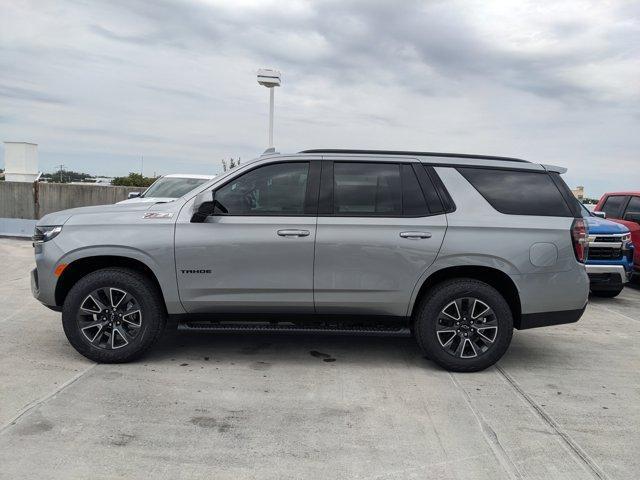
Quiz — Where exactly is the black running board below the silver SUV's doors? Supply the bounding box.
[178,321,411,337]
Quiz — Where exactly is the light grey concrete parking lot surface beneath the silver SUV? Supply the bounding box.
[0,238,640,480]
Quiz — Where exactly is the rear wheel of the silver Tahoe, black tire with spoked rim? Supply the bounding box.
[414,278,513,372]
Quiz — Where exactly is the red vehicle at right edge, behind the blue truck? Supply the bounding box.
[595,191,640,279]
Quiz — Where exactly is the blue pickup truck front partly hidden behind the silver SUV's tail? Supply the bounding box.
[582,205,633,298]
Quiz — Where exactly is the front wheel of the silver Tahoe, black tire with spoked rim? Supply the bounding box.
[62,268,166,363]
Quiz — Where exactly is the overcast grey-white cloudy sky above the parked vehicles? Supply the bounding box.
[0,0,640,196]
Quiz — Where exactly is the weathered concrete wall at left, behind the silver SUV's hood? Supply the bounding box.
[0,181,144,223]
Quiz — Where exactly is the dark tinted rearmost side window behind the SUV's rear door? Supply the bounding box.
[458,167,573,217]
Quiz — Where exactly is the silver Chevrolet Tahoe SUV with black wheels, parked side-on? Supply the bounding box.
[32,150,589,371]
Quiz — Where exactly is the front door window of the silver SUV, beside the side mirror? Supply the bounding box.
[216,162,309,215]
